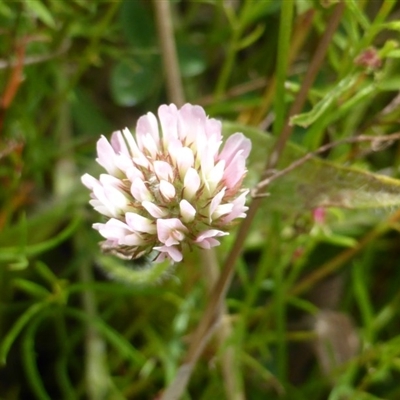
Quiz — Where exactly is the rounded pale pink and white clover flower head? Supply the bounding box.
[81,104,251,262]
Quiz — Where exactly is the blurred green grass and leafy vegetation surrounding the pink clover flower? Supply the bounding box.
[0,0,400,400]
